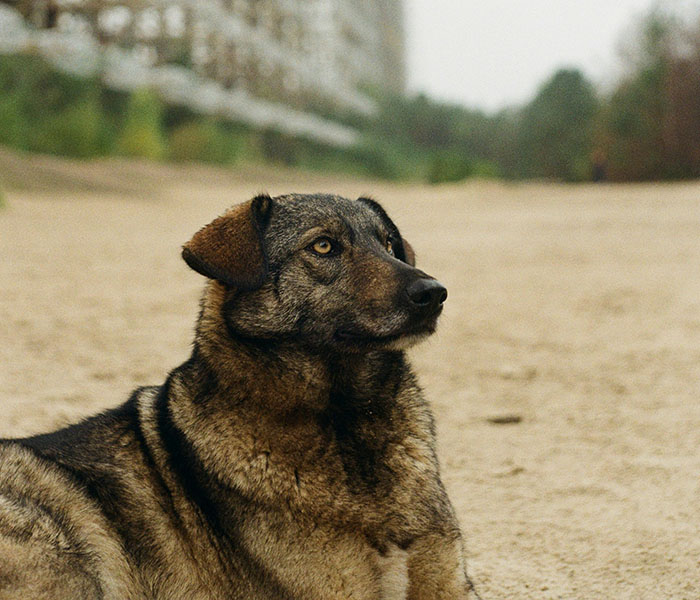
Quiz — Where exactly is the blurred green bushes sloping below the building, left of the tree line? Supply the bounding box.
[0,55,394,178]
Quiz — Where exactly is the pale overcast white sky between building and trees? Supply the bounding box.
[405,0,700,111]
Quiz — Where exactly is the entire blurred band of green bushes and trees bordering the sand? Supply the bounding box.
[0,11,700,183]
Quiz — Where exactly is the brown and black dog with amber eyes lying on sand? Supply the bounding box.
[0,194,478,600]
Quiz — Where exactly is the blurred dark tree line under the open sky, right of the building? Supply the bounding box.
[364,11,700,182]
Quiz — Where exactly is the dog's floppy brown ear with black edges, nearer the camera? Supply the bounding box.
[182,194,272,290]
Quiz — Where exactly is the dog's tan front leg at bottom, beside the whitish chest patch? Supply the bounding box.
[407,524,478,600]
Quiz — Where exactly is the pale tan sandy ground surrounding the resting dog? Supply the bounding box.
[0,152,700,600]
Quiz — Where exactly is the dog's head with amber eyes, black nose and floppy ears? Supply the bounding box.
[182,194,447,352]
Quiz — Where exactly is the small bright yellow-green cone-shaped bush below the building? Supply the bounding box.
[115,90,166,160]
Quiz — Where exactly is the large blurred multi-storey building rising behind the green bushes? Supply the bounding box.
[5,0,405,143]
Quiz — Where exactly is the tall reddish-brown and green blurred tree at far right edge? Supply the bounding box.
[597,12,700,181]
